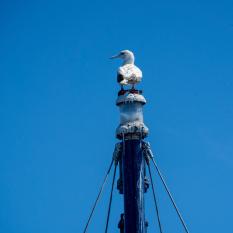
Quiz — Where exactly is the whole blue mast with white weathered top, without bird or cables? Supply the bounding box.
[116,89,148,233]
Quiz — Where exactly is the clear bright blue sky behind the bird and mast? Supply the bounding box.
[0,0,233,233]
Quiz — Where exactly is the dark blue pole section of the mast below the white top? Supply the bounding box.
[122,140,145,233]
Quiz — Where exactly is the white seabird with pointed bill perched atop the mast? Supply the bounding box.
[111,50,142,90]
